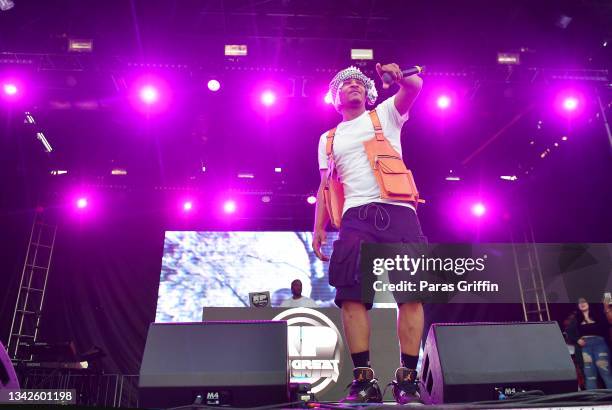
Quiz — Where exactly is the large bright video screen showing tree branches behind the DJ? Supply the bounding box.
[155,231,337,322]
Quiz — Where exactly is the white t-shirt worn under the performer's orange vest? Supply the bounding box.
[319,96,414,215]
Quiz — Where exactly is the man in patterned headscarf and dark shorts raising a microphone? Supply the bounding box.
[312,64,425,404]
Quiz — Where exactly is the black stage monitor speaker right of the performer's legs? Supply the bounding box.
[419,322,578,404]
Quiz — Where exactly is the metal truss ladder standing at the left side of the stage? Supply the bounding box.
[8,208,57,361]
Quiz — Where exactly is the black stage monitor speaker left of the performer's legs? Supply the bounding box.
[139,321,289,408]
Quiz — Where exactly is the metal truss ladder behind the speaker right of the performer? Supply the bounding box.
[510,217,550,322]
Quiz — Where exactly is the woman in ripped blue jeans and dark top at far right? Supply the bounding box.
[568,298,612,390]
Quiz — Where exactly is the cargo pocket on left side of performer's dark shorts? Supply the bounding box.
[329,238,362,287]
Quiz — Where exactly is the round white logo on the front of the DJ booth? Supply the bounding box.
[272,308,344,394]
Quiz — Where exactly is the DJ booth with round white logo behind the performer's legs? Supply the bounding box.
[202,307,399,401]
